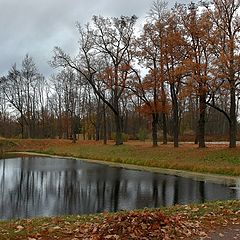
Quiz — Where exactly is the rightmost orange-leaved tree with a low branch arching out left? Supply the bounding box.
[203,0,240,148]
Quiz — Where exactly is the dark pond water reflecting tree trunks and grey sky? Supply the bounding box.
[0,157,240,219]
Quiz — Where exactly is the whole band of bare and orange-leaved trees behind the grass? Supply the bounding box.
[0,0,240,147]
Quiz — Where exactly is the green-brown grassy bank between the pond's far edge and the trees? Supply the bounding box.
[4,140,240,176]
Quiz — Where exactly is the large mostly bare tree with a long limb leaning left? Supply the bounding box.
[52,16,136,145]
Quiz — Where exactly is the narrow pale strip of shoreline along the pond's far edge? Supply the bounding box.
[8,152,240,185]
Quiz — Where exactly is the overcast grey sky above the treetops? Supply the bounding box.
[0,0,190,76]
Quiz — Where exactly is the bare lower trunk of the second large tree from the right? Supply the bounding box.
[198,93,206,148]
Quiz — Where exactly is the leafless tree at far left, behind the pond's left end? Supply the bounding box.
[3,55,44,138]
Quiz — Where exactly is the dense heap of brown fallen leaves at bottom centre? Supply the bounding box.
[71,211,182,240]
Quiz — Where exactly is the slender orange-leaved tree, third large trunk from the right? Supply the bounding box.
[163,8,187,147]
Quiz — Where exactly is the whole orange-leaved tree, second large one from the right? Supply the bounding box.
[178,3,216,147]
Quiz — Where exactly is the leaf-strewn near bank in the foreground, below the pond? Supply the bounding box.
[0,200,240,240]
